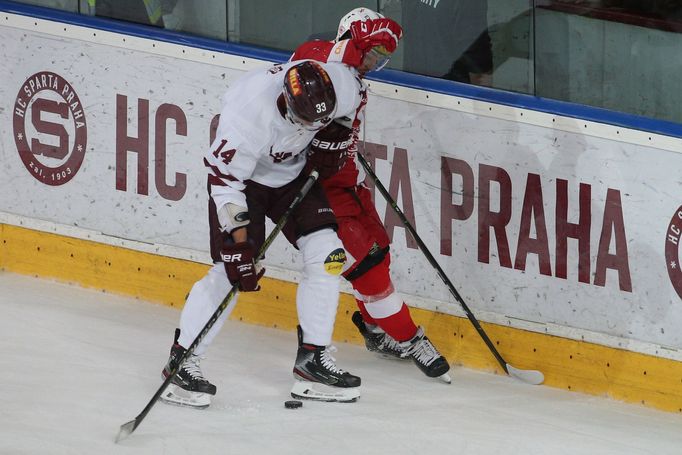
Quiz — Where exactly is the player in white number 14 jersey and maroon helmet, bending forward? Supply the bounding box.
[162,60,366,407]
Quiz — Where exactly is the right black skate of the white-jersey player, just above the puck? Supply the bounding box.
[291,326,360,403]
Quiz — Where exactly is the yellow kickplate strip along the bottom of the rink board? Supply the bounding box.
[0,224,682,412]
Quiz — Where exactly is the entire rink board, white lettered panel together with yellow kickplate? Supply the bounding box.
[0,8,682,411]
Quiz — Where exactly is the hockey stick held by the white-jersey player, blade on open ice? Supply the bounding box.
[116,170,319,442]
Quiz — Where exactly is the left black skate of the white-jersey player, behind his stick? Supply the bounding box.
[159,329,216,409]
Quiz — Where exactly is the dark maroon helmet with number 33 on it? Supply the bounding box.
[283,60,336,131]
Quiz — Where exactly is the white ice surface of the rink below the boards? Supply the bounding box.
[0,273,682,455]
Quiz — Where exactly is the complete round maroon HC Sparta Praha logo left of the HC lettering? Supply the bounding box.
[14,71,87,185]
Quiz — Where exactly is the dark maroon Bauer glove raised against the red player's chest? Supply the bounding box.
[304,122,354,179]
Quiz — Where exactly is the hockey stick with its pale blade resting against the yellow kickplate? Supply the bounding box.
[357,151,545,385]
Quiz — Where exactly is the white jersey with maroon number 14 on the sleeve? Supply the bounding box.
[204,61,366,214]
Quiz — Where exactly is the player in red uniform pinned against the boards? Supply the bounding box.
[291,8,450,383]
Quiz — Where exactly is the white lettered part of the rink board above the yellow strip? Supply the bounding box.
[0,15,682,348]
